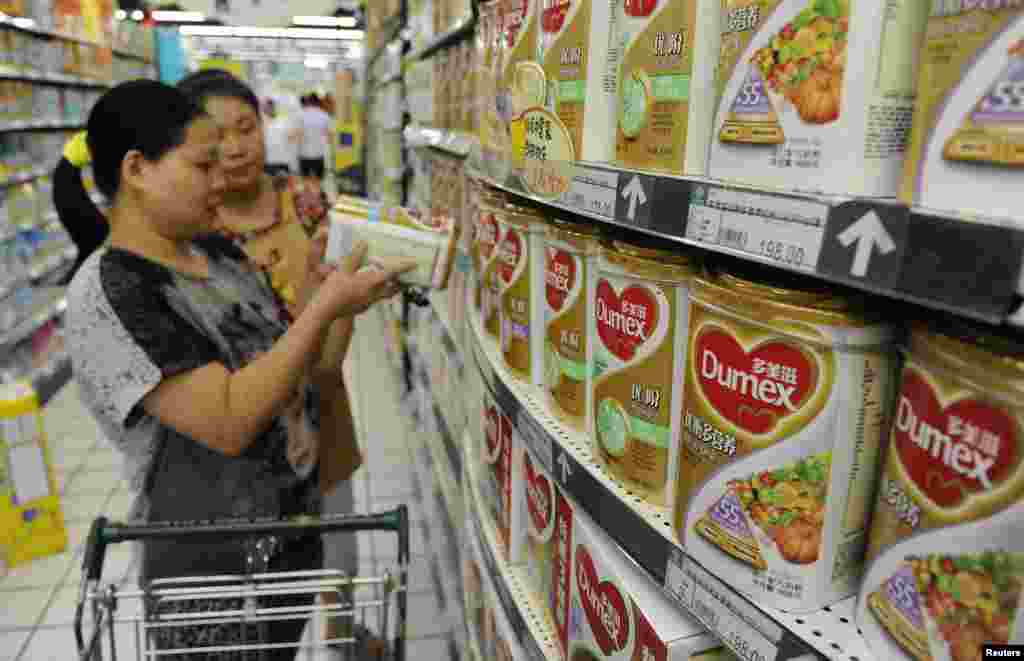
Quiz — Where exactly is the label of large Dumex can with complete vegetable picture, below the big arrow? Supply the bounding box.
[676,300,894,609]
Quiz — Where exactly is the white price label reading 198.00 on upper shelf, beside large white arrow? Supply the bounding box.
[686,186,829,272]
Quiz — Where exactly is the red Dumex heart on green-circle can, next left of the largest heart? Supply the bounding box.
[594,279,657,362]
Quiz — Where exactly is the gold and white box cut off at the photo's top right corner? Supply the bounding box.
[900,0,1024,225]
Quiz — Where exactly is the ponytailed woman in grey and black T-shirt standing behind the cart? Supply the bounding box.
[54,81,411,659]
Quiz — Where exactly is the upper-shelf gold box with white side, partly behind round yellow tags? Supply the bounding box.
[538,0,620,163]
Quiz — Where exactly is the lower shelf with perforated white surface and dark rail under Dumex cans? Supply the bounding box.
[471,313,873,661]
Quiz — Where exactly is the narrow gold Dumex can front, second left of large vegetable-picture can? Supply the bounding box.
[544,240,594,429]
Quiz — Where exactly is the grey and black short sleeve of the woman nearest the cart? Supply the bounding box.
[67,251,217,428]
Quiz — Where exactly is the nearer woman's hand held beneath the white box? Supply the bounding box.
[313,241,416,319]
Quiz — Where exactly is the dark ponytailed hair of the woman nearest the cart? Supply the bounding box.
[53,80,204,277]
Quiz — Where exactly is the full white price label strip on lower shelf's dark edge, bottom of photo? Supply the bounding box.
[665,549,783,661]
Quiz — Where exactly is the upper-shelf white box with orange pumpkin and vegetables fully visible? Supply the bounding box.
[709,0,931,196]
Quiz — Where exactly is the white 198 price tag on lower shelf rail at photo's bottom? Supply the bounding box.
[683,561,782,661]
